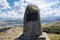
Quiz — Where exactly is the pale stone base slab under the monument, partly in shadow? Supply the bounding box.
[15,32,50,40]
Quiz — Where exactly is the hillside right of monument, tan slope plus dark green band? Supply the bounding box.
[42,21,60,34]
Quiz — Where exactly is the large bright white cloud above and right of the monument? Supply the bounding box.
[26,0,60,17]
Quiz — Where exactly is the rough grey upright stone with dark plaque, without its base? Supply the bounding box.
[23,5,42,37]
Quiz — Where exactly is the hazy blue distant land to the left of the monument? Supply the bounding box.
[0,19,23,27]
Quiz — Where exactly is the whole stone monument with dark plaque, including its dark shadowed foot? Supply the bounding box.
[15,5,50,40]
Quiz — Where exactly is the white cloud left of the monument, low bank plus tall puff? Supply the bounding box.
[0,0,25,18]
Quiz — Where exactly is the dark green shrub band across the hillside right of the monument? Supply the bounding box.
[42,26,60,34]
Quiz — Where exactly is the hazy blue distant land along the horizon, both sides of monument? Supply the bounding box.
[0,17,60,27]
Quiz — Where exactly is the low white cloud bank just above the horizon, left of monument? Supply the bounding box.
[0,10,23,18]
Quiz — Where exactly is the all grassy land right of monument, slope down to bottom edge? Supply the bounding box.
[42,21,60,40]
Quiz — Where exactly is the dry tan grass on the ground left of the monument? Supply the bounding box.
[0,27,23,40]
